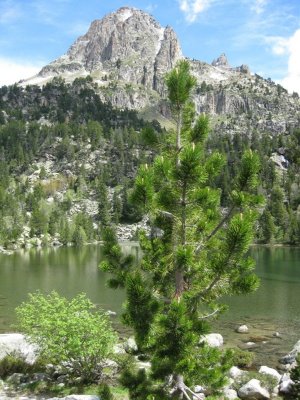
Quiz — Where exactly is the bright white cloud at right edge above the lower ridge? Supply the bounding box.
[280,29,300,94]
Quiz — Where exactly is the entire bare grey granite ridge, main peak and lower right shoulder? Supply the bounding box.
[22,7,300,133]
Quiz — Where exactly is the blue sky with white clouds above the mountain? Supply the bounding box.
[0,0,300,94]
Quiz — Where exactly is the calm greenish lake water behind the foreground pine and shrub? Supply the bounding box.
[0,244,300,365]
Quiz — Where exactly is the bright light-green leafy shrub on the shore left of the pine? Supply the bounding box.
[16,292,117,382]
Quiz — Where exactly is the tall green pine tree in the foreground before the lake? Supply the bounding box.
[102,61,261,400]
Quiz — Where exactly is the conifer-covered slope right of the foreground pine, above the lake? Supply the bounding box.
[208,128,300,245]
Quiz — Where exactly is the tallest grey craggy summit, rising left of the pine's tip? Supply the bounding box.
[27,7,182,90]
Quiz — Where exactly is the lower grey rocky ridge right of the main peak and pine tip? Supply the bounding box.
[191,55,300,135]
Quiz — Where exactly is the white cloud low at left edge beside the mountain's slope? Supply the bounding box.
[0,58,42,86]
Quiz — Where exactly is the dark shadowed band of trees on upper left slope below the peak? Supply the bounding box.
[0,76,161,131]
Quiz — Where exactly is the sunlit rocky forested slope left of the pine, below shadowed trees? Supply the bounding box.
[0,114,164,248]
